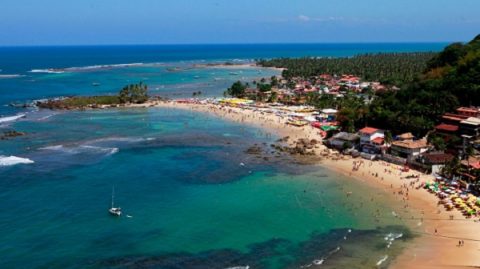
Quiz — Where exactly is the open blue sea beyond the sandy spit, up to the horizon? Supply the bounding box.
[0,43,447,117]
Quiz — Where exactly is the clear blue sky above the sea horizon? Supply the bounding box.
[0,0,480,46]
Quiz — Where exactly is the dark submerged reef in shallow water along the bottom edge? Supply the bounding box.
[86,226,412,269]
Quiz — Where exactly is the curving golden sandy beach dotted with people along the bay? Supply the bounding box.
[131,101,480,268]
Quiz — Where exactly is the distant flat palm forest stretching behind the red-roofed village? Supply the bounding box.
[258,52,435,86]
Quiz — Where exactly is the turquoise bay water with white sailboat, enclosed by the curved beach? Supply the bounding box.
[0,109,410,268]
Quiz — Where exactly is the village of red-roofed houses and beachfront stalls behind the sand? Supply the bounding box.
[177,74,480,194]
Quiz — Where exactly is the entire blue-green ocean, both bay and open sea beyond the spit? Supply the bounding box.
[0,43,445,268]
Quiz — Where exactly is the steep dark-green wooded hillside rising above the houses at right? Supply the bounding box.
[366,36,480,135]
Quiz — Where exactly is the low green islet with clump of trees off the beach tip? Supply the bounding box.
[37,83,148,109]
